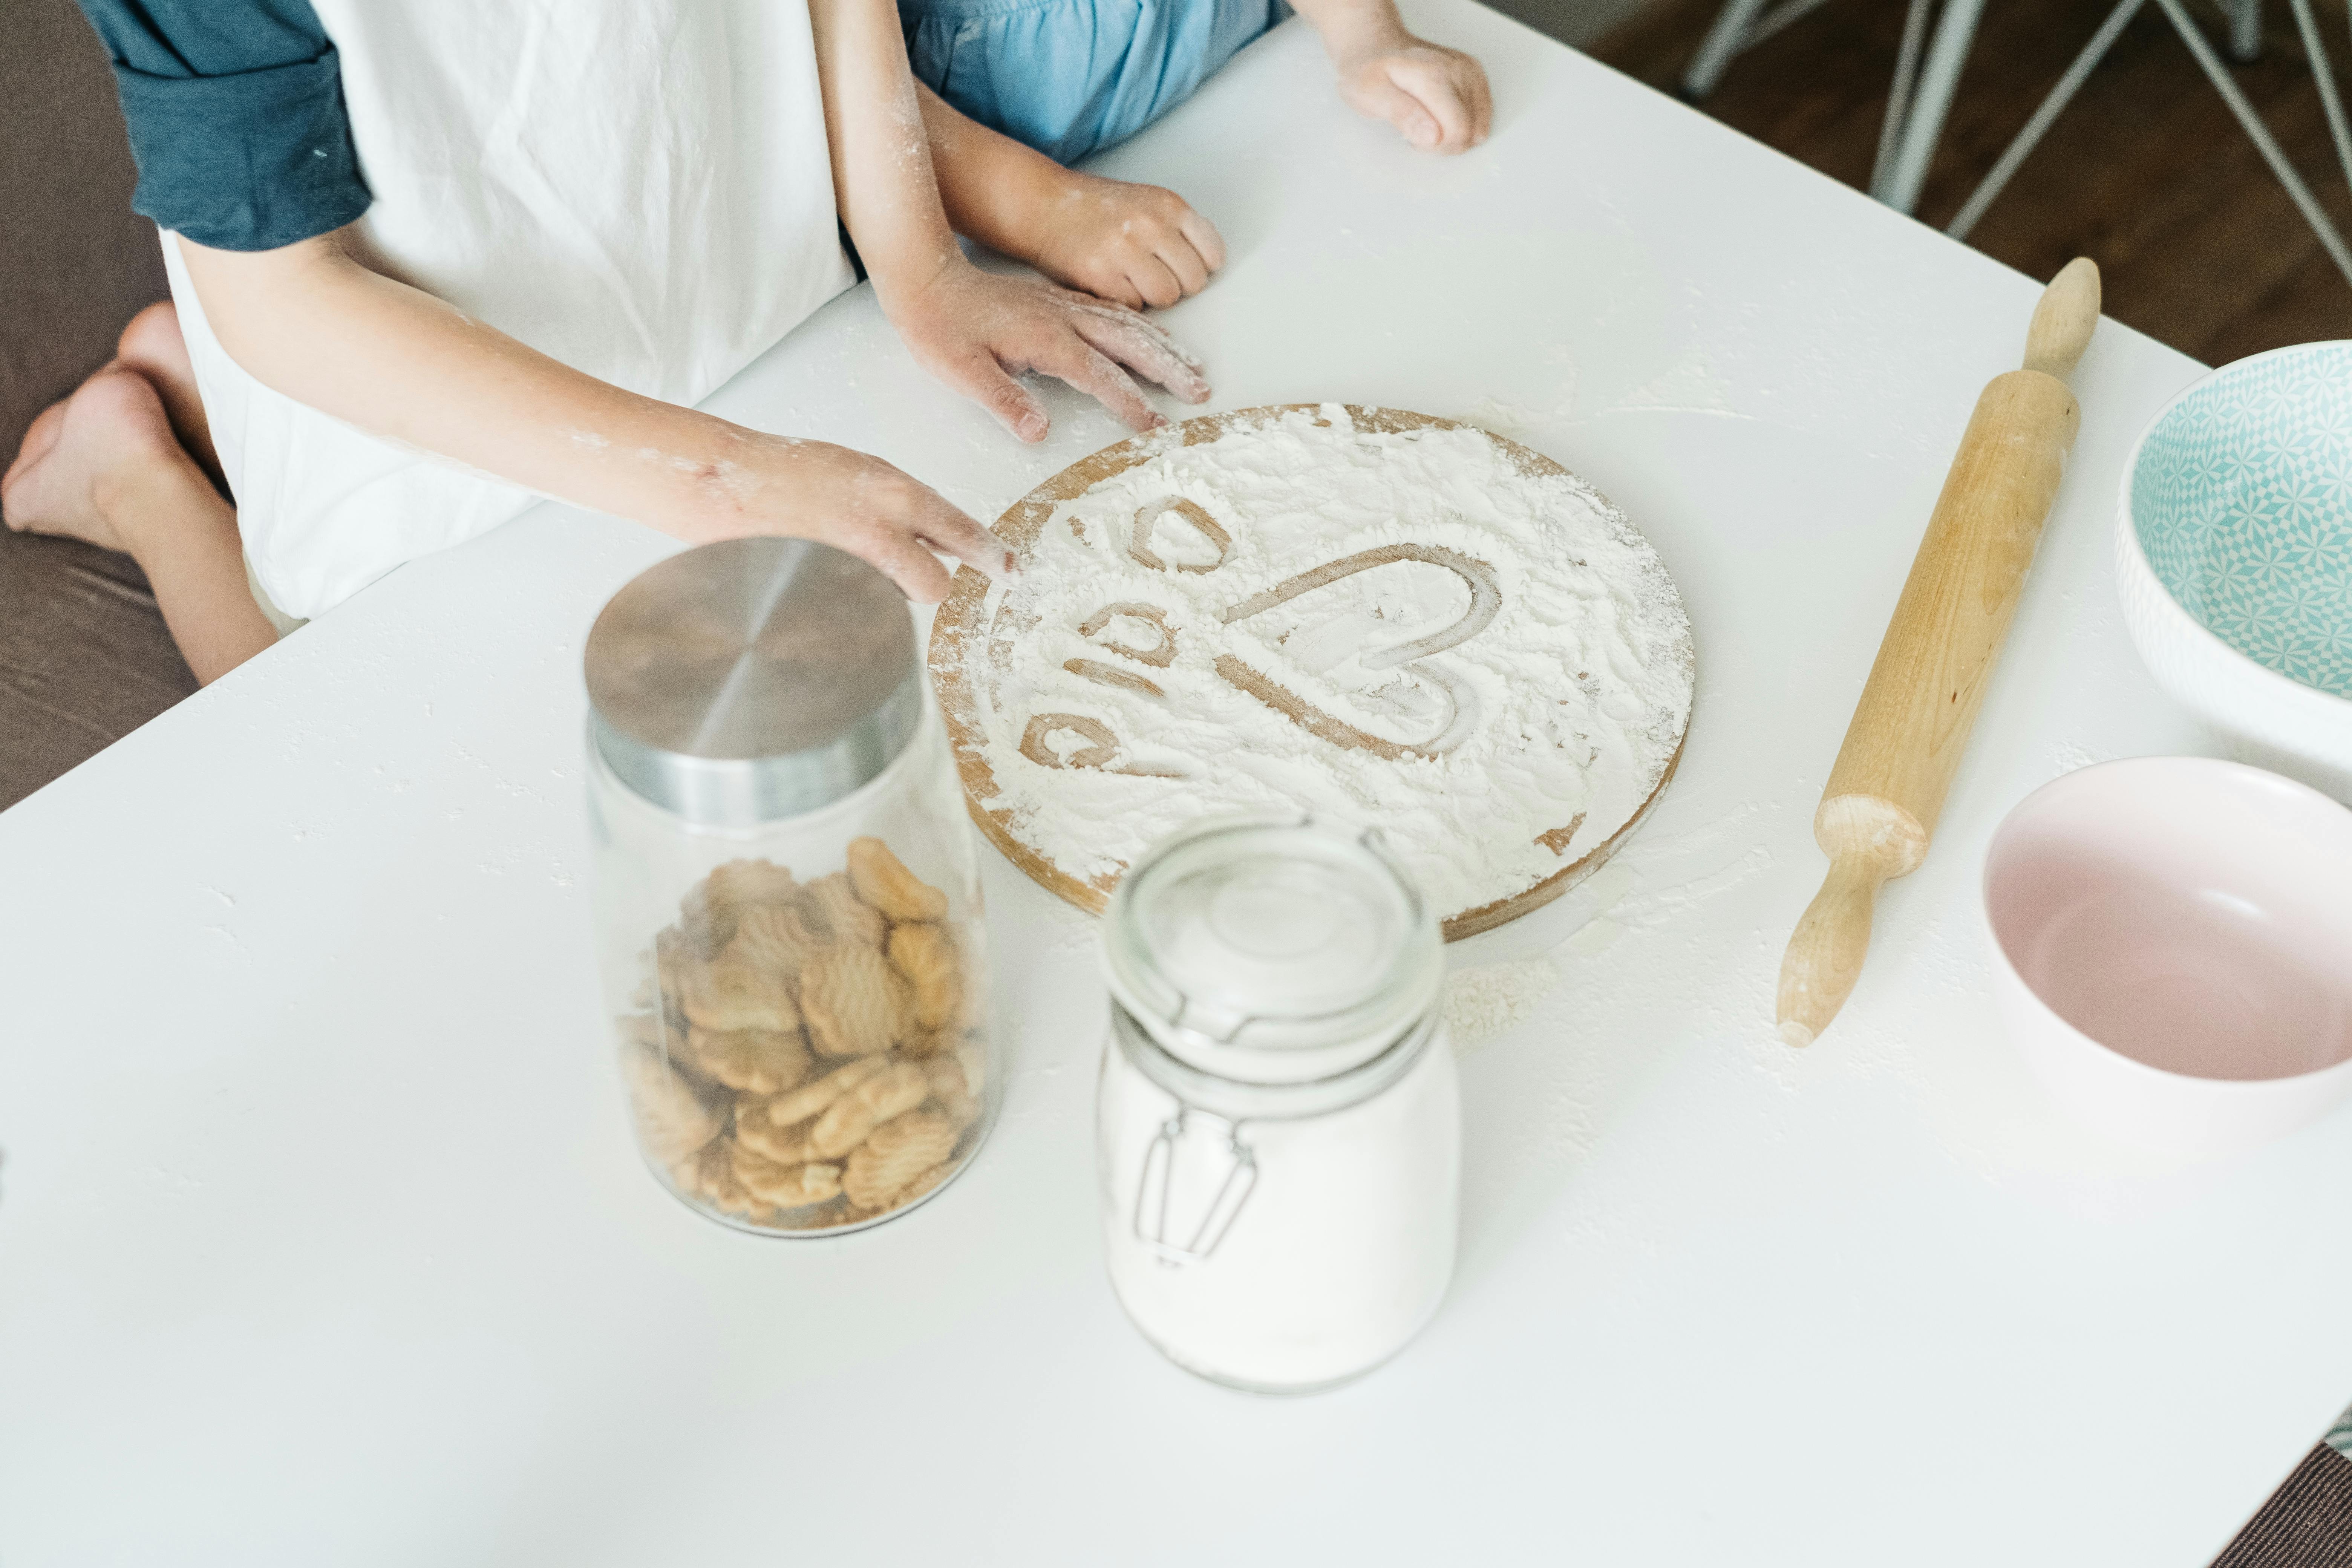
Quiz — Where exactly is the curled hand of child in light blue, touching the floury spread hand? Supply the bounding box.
[1028,169,1225,310]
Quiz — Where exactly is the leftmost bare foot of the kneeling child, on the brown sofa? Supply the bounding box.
[0,367,190,555]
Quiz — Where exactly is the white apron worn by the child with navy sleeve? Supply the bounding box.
[165,0,854,618]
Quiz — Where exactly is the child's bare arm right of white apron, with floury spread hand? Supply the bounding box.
[809,0,1209,442]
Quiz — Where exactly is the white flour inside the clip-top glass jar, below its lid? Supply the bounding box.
[1096,1027,1461,1392]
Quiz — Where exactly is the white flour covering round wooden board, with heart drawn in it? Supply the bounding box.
[960,404,1691,914]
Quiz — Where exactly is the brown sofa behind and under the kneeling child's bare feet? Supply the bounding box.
[0,0,195,808]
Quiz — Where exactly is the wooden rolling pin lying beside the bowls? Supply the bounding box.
[1781,256,2098,1046]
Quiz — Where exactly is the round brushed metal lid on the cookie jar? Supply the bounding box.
[586,538,922,827]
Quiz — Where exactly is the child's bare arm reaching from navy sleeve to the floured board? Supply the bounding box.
[179,230,1009,602]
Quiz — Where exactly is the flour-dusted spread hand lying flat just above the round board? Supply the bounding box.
[875,256,1209,442]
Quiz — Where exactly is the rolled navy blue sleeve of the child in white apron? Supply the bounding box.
[80,0,369,251]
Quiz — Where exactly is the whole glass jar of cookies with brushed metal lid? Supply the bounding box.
[586,538,997,1234]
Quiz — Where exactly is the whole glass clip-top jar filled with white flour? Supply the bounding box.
[1096,818,1461,1394]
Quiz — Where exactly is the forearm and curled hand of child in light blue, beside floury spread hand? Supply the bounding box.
[915,82,1225,310]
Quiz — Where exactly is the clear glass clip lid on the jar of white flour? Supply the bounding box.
[1103,816,1444,1086]
